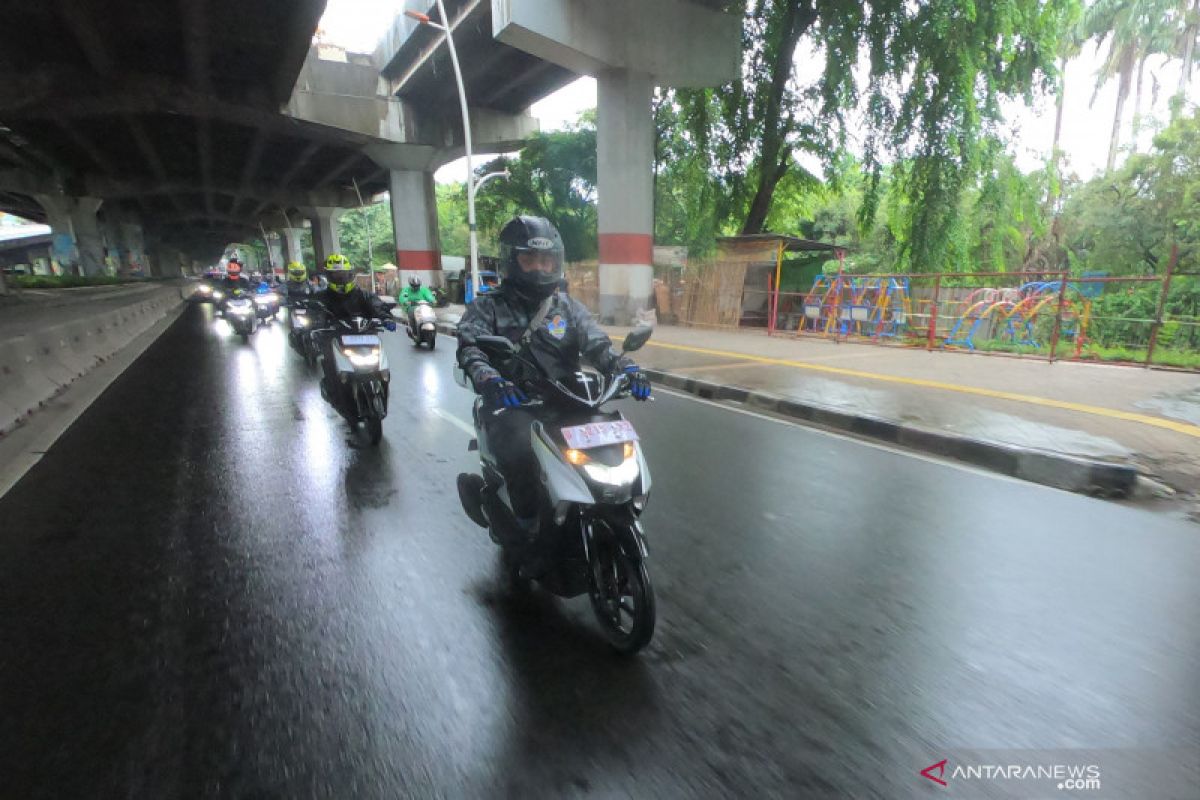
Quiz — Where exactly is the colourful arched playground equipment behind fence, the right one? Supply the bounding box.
[943,281,1091,350]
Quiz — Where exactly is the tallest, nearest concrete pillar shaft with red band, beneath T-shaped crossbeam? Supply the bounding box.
[596,70,654,325]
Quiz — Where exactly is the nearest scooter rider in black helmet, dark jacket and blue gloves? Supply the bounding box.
[457,216,650,536]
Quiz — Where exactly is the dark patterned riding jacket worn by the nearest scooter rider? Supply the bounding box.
[458,285,632,391]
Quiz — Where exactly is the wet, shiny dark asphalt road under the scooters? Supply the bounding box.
[0,307,1200,798]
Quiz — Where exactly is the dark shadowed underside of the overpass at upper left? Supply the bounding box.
[0,0,386,256]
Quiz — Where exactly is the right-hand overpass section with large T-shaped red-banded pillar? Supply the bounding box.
[374,0,742,321]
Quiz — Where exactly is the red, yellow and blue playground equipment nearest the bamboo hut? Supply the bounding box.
[798,273,912,338]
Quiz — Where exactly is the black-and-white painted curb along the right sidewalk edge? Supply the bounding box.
[642,367,1138,498]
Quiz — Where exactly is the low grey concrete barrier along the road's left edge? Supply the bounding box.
[0,285,184,435]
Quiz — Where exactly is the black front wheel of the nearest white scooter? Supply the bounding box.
[588,527,655,655]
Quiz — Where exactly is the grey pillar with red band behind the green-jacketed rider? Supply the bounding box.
[388,169,444,287]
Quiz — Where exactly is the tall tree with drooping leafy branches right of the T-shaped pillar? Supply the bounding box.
[676,0,1076,269]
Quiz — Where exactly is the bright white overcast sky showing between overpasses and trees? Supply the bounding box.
[320,0,1200,188]
